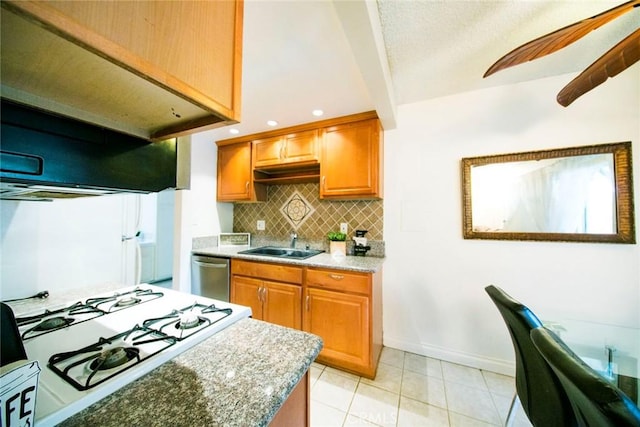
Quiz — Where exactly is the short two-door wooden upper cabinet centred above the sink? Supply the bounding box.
[253,129,319,169]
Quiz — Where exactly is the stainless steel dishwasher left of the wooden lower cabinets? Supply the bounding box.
[191,255,229,301]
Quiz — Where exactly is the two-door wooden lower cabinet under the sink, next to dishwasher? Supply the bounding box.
[231,260,302,330]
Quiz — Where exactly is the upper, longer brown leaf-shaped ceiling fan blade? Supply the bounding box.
[483,0,640,77]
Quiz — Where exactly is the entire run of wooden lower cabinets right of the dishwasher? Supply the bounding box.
[231,259,382,379]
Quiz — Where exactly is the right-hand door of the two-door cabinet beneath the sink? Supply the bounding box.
[262,281,302,330]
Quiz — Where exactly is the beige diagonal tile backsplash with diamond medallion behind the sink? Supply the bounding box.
[233,183,383,251]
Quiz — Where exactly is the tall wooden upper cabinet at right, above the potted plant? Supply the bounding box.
[320,119,382,199]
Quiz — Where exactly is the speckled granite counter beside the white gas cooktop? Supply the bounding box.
[61,319,322,427]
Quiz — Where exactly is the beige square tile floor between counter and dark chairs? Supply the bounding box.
[311,347,531,427]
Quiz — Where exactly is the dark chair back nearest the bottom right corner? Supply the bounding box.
[531,327,640,427]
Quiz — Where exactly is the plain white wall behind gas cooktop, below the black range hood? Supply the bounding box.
[0,195,130,299]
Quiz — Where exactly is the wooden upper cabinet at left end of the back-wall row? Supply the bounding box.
[217,142,267,202]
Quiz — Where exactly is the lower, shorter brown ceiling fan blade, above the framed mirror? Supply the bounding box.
[557,29,640,107]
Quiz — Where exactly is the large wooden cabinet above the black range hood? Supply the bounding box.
[1,0,244,140]
